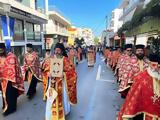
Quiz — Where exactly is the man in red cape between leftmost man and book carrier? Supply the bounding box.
[23,43,42,99]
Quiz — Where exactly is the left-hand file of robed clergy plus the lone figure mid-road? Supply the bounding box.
[0,42,95,120]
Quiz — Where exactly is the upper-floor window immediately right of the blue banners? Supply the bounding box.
[13,20,24,41]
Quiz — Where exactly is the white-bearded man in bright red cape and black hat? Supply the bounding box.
[118,54,160,120]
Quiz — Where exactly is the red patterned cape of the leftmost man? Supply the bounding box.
[0,52,24,95]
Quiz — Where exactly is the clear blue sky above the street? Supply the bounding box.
[37,0,120,36]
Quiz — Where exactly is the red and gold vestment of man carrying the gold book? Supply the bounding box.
[44,57,77,120]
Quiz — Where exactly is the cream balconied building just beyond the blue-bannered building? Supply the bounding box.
[44,7,71,49]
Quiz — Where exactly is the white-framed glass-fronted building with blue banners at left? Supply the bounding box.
[0,0,47,63]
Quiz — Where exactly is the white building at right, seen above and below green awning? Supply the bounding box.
[120,0,151,45]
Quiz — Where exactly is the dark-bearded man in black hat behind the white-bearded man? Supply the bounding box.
[119,44,148,97]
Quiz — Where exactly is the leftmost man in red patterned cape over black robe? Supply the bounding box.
[0,43,24,115]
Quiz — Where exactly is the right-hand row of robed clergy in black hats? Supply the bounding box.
[104,44,160,120]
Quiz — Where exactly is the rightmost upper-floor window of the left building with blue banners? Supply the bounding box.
[26,22,34,40]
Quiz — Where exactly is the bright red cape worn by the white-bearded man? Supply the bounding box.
[118,70,160,120]
